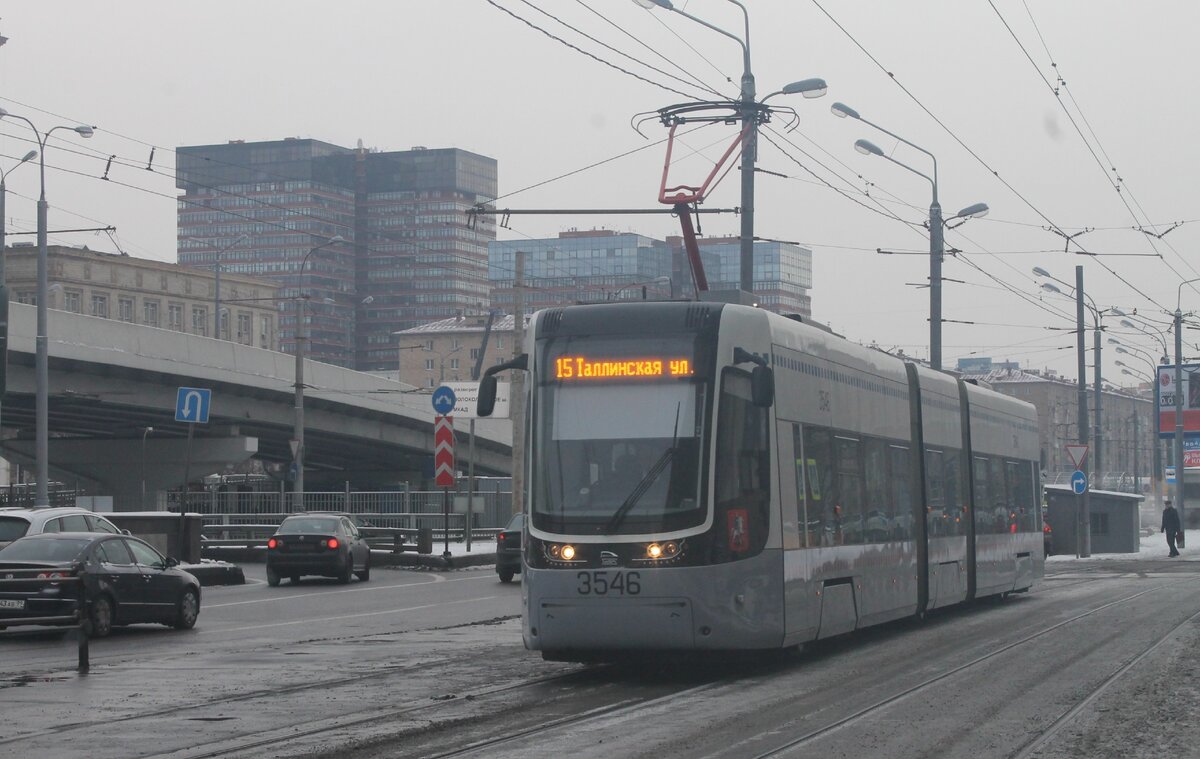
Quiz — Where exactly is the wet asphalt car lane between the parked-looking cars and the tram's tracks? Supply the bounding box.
[0,564,520,677]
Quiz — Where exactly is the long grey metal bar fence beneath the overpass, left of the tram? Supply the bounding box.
[175,490,512,531]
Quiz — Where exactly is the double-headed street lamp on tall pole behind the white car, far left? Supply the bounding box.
[0,108,95,508]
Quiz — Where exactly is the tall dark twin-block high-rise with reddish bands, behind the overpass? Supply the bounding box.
[176,139,497,371]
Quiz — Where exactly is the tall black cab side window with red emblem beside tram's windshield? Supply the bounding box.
[715,371,770,555]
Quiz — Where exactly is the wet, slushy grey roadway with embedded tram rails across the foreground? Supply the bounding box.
[0,560,1200,759]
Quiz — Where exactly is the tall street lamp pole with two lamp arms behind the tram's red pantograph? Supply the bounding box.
[634,0,828,293]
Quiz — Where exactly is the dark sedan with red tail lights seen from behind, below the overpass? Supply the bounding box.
[266,512,371,587]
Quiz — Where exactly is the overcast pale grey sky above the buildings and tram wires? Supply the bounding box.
[0,0,1200,381]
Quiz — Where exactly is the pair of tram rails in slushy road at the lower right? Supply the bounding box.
[752,582,1185,759]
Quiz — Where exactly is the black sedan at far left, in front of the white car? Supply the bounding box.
[0,532,200,638]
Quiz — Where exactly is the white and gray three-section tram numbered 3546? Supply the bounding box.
[480,301,1044,661]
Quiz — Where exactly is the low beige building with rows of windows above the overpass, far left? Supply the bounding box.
[4,244,280,351]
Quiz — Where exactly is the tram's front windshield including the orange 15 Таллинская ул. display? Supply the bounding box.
[532,340,707,534]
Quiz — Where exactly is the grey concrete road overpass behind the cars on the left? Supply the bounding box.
[0,303,512,508]
